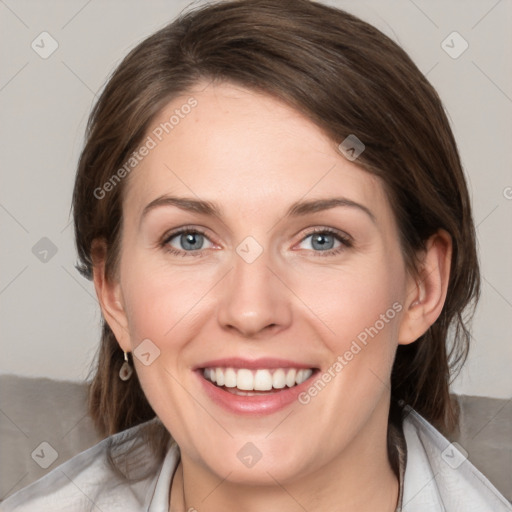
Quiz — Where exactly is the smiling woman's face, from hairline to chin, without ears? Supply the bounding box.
[107,84,412,484]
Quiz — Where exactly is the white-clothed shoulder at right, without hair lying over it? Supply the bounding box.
[403,409,512,512]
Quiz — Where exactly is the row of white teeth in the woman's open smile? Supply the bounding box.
[203,368,313,391]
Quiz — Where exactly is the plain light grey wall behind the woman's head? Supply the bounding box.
[0,0,512,399]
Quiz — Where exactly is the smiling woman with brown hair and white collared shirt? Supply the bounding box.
[2,0,512,512]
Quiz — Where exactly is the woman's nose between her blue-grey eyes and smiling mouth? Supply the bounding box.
[217,245,293,339]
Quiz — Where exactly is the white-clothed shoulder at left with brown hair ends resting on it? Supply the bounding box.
[0,420,164,512]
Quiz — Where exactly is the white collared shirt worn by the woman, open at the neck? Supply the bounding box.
[0,409,512,512]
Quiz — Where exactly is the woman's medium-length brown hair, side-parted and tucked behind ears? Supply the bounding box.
[73,0,480,472]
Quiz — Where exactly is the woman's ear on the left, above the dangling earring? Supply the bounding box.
[91,239,131,352]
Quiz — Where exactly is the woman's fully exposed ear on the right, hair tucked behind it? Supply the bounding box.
[398,229,452,345]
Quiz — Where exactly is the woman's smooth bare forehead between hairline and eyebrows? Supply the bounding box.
[124,84,389,222]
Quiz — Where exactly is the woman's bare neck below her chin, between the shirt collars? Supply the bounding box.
[170,402,399,512]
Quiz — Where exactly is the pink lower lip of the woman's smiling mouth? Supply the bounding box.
[195,370,317,415]
